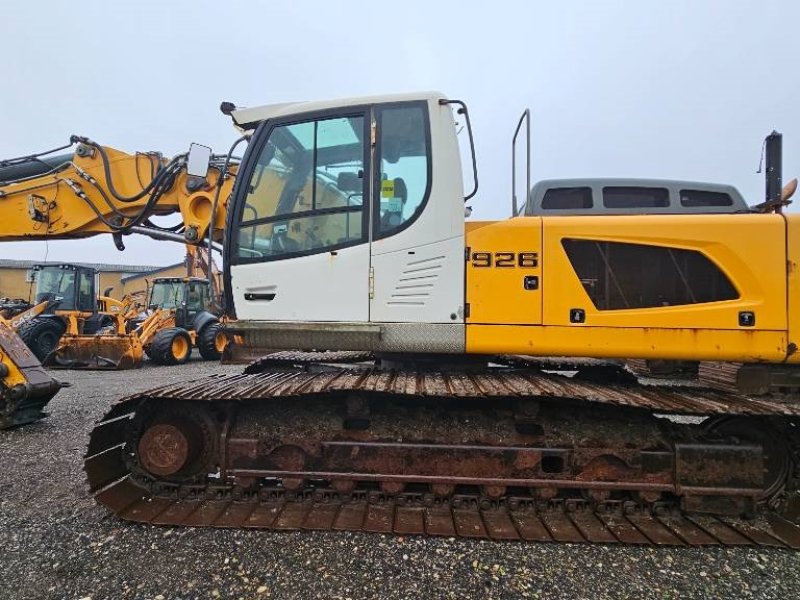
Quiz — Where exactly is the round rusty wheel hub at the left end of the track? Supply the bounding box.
[139,423,197,477]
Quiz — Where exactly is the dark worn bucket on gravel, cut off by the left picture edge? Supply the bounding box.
[0,319,66,429]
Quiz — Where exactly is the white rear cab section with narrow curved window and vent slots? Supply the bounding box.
[370,99,464,324]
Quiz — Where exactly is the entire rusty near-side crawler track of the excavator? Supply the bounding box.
[85,368,800,548]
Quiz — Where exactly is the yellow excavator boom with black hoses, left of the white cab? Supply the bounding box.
[0,136,236,246]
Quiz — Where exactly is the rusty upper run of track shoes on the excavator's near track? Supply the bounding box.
[119,370,800,416]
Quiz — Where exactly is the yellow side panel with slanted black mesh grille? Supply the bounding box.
[543,214,787,332]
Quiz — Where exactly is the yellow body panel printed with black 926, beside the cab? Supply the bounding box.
[466,217,542,325]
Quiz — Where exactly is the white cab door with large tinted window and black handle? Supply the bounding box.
[228,107,370,322]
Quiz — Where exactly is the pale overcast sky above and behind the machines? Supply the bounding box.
[0,0,800,265]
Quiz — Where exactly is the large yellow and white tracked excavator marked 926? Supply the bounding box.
[0,93,800,548]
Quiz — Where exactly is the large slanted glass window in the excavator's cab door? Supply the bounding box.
[237,114,366,260]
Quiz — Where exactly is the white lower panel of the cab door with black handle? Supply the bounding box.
[231,243,369,321]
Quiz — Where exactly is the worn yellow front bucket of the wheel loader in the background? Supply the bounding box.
[44,334,144,370]
